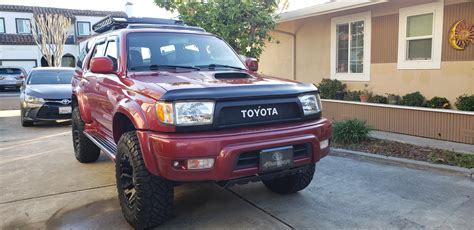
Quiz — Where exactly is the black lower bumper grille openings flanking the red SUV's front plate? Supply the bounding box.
[236,143,312,169]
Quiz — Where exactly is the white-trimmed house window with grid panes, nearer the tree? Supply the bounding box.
[331,12,371,81]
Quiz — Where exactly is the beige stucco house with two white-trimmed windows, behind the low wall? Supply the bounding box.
[260,0,474,102]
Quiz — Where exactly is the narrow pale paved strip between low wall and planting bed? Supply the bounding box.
[370,131,474,154]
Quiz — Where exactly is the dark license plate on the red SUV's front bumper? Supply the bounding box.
[260,146,293,172]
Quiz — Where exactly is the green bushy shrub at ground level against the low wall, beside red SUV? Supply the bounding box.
[332,119,372,144]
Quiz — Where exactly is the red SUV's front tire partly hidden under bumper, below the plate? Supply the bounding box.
[262,164,315,194]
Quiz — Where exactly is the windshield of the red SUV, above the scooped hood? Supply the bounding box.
[128,33,245,70]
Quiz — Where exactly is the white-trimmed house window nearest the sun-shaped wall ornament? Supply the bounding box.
[397,2,443,69]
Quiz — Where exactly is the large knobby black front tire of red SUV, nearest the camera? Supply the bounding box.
[115,131,174,229]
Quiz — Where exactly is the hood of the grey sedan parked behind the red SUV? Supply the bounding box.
[25,84,72,99]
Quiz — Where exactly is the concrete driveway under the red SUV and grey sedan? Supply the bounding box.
[0,94,474,229]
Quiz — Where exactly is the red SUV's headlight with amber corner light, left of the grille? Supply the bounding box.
[157,101,214,126]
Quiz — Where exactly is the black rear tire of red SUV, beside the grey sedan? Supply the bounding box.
[71,106,100,163]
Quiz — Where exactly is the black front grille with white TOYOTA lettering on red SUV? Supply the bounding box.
[217,99,302,127]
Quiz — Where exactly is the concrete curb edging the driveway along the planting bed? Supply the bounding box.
[329,148,474,181]
